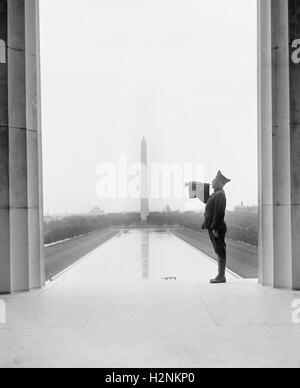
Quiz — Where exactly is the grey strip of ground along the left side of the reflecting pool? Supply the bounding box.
[45,229,119,280]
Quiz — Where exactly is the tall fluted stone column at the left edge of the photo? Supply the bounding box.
[0,0,45,293]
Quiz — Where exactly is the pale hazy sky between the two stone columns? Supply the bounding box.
[40,0,257,213]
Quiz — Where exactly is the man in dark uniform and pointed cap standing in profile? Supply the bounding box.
[202,171,231,284]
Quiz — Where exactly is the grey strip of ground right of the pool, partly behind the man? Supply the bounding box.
[172,228,258,279]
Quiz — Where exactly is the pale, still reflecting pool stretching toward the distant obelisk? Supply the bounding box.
[64,229,233,283]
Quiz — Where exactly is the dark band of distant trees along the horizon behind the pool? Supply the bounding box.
[45,211,258,246]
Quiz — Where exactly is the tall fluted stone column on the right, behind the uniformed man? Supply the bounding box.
[258,0,300,289]
